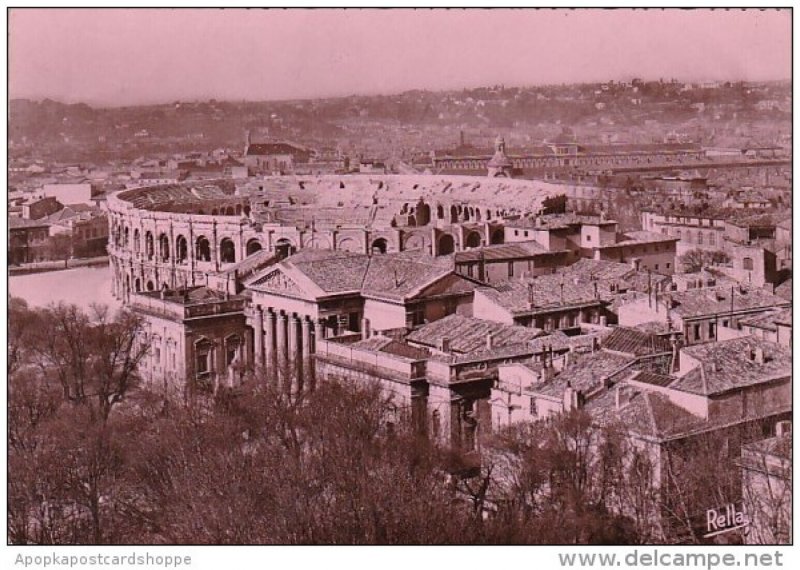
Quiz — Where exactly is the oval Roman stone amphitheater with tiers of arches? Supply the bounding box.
[108,175,565,300]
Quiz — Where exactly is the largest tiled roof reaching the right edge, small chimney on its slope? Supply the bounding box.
[672,336,792,395]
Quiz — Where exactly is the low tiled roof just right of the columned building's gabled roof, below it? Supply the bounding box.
[407,315,543,354]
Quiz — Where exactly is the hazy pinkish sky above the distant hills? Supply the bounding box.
[9,9,791,105]
